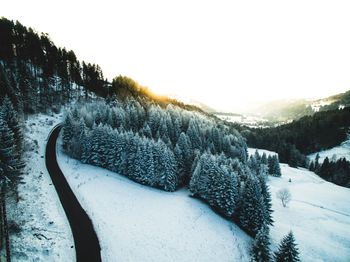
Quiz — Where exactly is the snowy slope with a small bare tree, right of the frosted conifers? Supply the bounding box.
[248,149,350,262]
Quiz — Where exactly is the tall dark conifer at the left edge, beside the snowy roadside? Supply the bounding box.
[0,97,23,196]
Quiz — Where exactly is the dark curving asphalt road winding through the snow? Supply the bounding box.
[45,125,101,262]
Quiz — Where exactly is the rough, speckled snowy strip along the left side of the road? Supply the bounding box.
[8,114,75,261]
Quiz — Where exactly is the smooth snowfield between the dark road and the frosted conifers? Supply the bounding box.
[58,145,251,262]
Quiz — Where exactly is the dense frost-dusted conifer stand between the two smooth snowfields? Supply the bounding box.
[63,100,281,236]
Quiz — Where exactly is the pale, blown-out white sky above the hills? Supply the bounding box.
[0,0,350,110]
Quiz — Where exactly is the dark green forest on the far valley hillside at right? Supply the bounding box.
[241,107,350,167]
